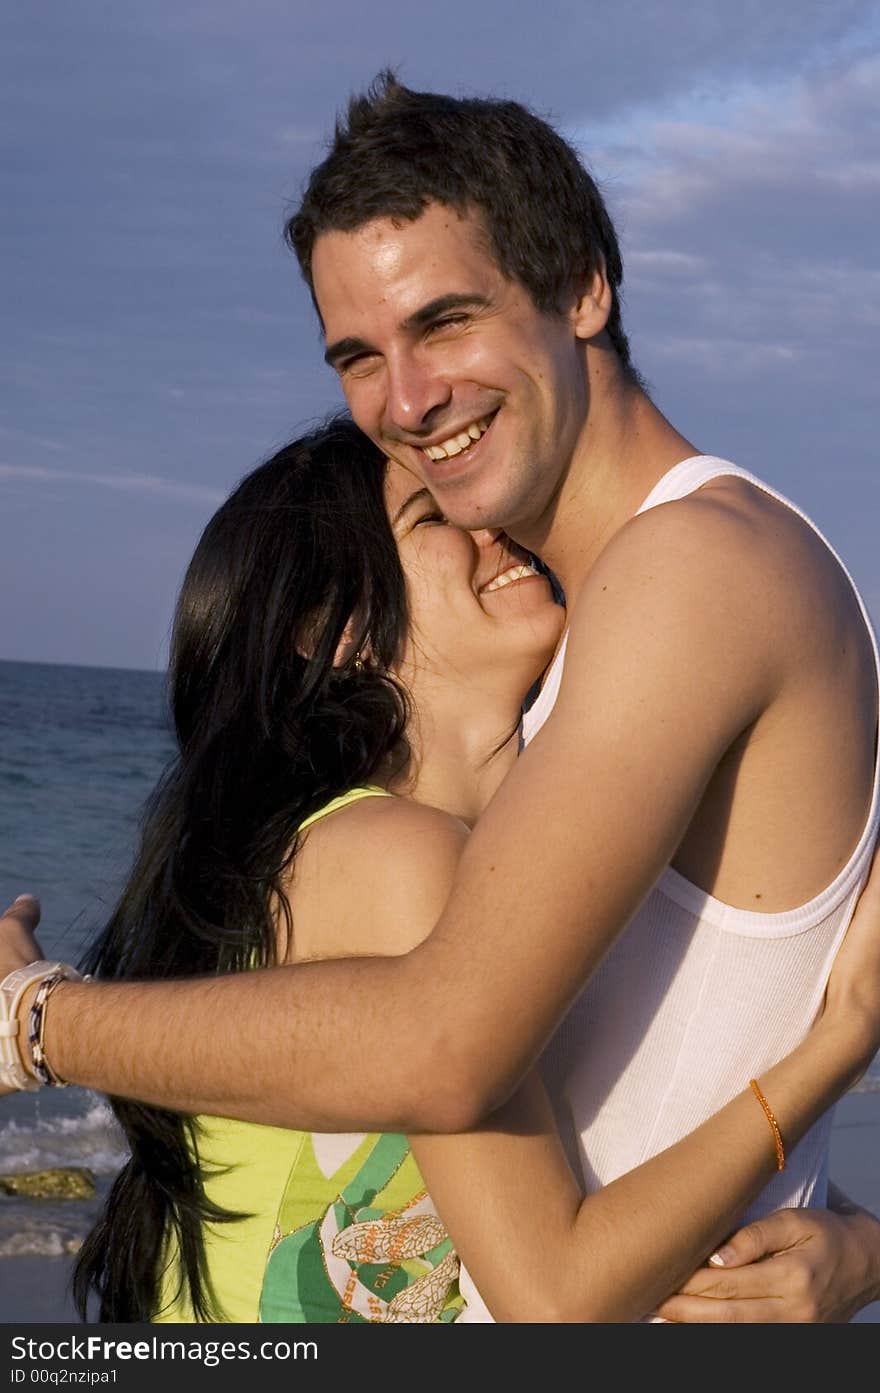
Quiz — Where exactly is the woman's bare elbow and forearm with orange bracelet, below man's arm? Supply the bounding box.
[412,1022,870,1322]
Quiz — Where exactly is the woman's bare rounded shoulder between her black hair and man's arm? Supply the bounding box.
[290,797,468,960]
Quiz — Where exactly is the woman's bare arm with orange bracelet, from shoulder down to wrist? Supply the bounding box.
[285,801,874,1321]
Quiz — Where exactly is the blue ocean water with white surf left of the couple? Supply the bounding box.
[0,662,880,1259]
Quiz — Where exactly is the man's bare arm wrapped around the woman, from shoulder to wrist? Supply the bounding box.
[0,503,874,1131]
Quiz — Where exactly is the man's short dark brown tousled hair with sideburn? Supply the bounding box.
[284,70,638,379]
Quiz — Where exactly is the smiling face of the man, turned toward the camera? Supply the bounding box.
[312,203,588,543]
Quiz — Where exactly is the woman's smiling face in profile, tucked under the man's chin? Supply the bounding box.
[386,461,565,715]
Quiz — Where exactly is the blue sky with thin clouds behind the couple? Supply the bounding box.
[0,0,880,667]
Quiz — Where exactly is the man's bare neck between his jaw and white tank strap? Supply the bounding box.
[515,348,699,606]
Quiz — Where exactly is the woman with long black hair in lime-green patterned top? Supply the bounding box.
[70,421,880,1322]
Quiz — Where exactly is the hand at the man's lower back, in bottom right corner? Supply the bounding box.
[656,1202,880,1325]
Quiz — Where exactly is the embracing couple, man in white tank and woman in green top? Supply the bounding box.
[0,75,880,1322]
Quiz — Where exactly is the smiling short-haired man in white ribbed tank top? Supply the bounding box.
[0,77,880,1319]
